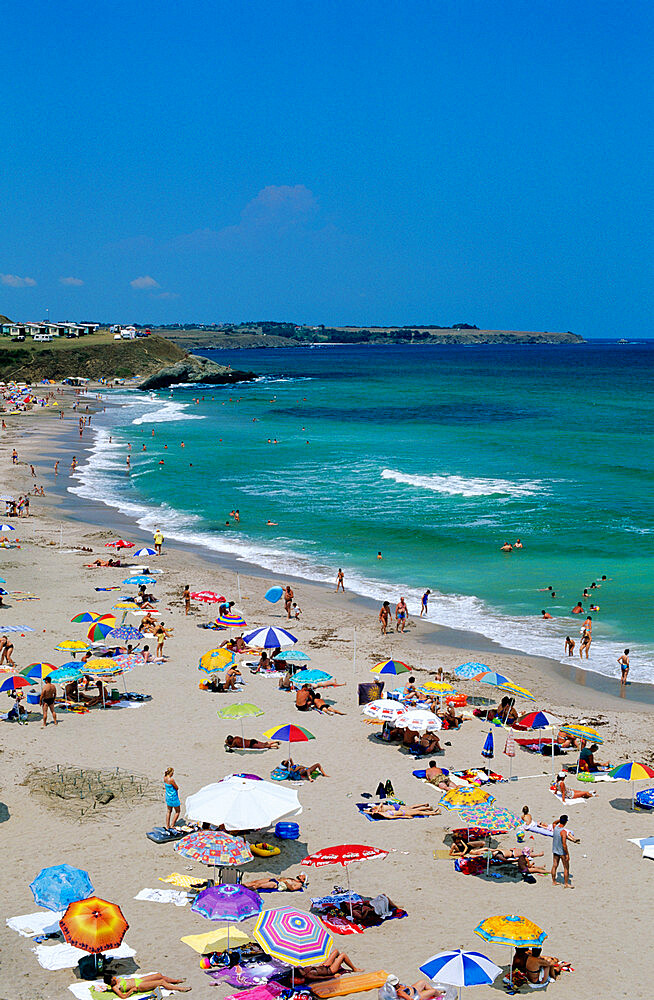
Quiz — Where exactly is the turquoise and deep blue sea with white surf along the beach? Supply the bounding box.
[72,341,654,683]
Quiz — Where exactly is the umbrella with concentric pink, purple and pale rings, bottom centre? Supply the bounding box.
[253,906,334,966]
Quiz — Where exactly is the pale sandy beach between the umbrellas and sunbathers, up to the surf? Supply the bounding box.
[0,395,654,1000]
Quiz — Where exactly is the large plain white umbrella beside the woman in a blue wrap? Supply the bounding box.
[185,774,302,830]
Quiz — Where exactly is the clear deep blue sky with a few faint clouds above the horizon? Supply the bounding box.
[0,0,654,336]
